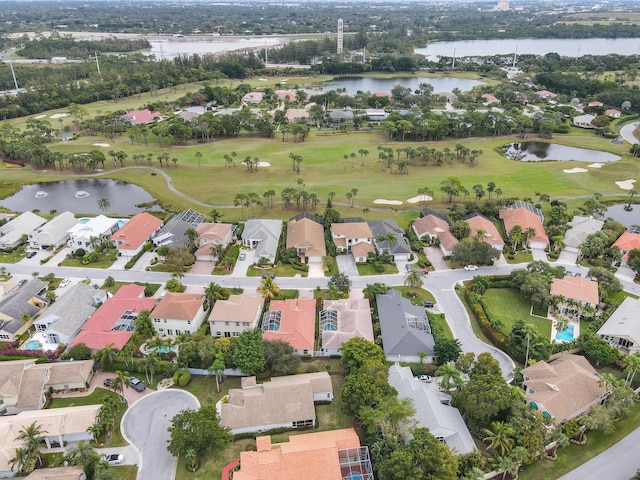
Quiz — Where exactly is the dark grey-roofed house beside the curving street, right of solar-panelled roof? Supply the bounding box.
[376,289,435,362]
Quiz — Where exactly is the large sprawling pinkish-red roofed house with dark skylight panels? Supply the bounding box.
[69,284,156,350]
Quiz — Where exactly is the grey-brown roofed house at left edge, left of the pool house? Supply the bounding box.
[0,279,48,342]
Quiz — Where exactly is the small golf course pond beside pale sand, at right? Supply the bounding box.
[502,142,620,163]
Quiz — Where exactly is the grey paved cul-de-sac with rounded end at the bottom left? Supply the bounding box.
[120,389,200,480]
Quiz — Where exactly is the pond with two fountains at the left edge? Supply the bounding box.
[0,178,161,215]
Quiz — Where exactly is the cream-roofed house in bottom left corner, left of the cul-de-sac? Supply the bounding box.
[0,405,102,478]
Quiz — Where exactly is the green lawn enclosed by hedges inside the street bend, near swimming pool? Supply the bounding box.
[483,288,551,340]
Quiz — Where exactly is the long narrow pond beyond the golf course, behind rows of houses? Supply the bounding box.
[308,77,482,95]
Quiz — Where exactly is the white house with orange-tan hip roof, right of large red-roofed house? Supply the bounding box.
[151,292,206,337]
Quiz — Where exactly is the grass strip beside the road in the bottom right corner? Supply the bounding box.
[519,403,640,480]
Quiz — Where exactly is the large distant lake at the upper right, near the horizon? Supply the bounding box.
[414,38,640,60]
